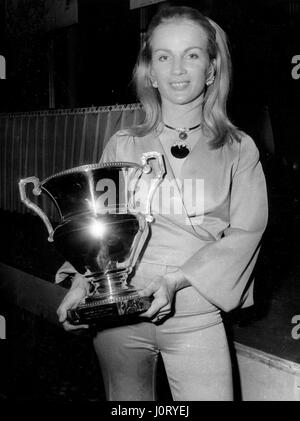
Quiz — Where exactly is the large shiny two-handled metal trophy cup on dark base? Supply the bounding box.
[19,152,165,324]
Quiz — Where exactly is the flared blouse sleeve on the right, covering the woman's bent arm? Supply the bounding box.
[180,136,268,312]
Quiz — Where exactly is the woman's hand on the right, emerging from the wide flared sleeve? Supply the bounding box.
[139,271,189,322]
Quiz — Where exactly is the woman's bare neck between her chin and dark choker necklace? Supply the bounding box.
[162,96,202,128]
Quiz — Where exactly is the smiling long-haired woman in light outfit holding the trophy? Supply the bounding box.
[58,7,267,400]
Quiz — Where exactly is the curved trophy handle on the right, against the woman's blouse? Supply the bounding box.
[141,151,166,222]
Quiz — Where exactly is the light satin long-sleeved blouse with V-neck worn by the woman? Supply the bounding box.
[101,131,268,314]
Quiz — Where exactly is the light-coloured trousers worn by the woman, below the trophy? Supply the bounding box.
[94,314,233,401]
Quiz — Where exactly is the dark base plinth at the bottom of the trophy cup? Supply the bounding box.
[67,291,152,326]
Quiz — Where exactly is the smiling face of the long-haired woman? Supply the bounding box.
[150,20,212,105]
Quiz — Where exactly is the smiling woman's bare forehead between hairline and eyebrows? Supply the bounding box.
[151,19,207,51]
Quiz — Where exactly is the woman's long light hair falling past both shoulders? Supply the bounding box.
[127,6,240,149]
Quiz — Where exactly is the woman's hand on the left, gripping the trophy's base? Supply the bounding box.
[57,273,89,331]
